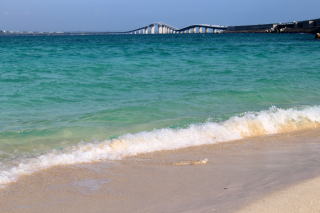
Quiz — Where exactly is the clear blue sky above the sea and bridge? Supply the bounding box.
[0,0,320,32]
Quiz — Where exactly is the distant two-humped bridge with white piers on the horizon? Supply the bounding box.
[121,23,227,34]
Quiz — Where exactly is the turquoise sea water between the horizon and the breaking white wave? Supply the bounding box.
[0,34,320,176]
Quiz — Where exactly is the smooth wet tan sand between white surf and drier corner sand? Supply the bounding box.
[0,129,320,213]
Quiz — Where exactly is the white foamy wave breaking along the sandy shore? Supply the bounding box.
[0,106,320,186]
